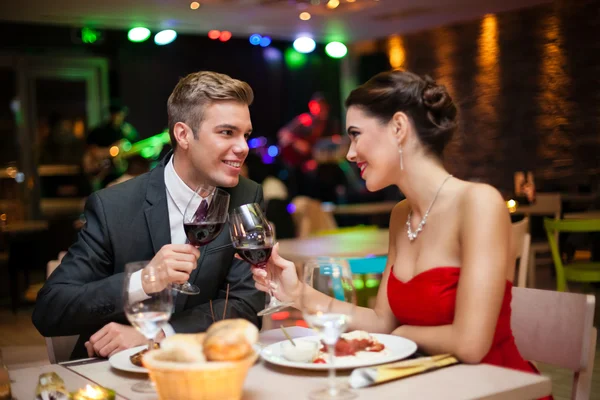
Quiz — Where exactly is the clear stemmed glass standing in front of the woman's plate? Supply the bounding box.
[300,258,356,400]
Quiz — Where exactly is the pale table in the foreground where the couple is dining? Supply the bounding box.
[9,327,552,400]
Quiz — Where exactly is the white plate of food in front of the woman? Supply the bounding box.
[260,333,417,370]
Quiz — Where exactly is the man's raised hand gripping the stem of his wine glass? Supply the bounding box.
[142,244,200,294]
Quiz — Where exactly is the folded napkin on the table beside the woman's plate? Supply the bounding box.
[350,354,458,389]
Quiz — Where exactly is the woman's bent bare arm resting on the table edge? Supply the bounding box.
[394,185,511,363]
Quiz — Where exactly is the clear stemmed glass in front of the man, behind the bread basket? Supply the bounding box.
[123,261,173,393]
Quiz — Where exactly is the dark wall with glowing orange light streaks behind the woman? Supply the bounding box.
[359,0,600,191]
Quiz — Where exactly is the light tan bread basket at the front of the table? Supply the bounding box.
[143,351,258,400]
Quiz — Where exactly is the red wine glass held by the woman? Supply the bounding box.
[229,203,291,316]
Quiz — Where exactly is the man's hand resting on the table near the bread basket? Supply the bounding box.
[85,322,148,357]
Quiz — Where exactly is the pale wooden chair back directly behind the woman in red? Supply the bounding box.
[511,287,597,400]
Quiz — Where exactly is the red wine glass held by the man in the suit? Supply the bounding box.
[173,185,229,295]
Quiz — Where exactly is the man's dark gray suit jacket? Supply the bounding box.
[33,156,265,359]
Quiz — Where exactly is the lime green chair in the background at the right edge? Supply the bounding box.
[544,218,600,292]
